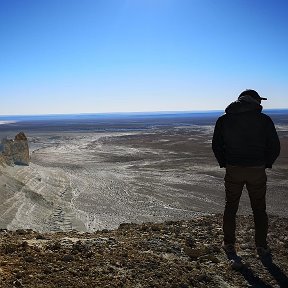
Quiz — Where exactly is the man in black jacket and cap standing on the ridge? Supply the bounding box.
[212,89,280,257]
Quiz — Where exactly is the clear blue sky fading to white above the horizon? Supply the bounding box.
[0,0,288,115]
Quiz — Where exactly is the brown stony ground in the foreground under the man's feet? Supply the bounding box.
[0,214,288,288]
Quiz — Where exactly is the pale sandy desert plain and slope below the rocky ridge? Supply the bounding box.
[0,126,288,232]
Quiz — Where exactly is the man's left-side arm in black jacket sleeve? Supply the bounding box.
[212,118,226,168]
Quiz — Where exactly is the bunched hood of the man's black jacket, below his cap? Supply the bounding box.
[225,96,263,114]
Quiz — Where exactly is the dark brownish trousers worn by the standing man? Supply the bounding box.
[223,166,268,248]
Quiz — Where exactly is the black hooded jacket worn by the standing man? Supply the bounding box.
[212,99,280,168]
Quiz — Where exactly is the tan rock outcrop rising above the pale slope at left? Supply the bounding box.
[0,132,30,166]
